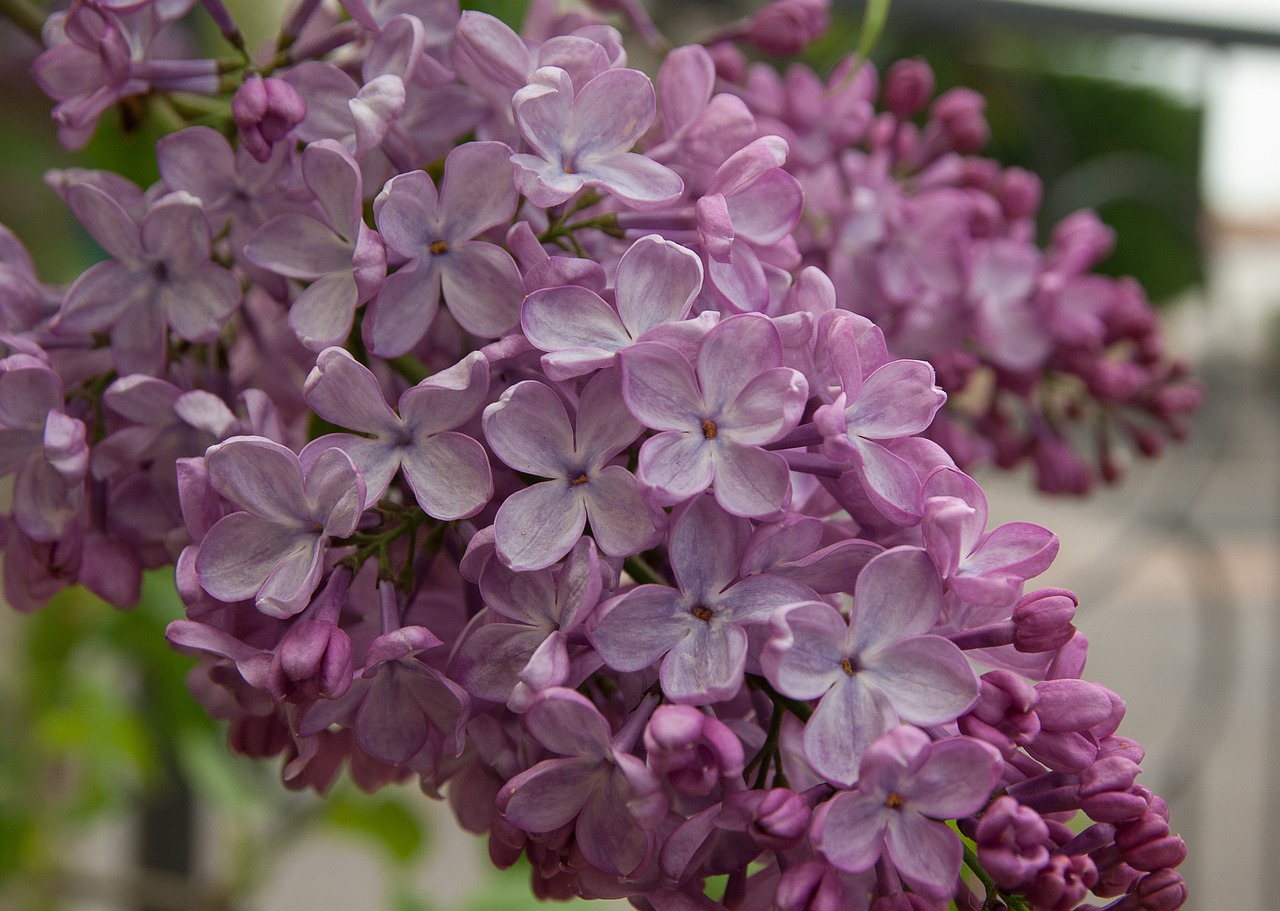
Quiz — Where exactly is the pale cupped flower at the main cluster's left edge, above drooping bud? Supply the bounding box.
[196,436,365,617]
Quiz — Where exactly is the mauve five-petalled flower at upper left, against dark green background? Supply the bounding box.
[51,183,241,375]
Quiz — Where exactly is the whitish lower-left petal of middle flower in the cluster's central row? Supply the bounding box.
[493,480,586,571]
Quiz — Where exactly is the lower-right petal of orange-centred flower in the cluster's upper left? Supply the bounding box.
[440,241,525,338]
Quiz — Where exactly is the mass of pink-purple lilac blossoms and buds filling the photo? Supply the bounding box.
[0,0,1185,911]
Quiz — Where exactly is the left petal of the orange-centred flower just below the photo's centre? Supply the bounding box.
[590,585,701,672]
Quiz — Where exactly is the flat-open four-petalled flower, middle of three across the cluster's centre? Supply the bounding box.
[484,371,655,569]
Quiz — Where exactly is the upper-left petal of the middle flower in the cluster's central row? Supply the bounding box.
[484,380,573,479]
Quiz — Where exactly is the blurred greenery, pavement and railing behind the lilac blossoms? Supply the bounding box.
[0,0,1280,911]
